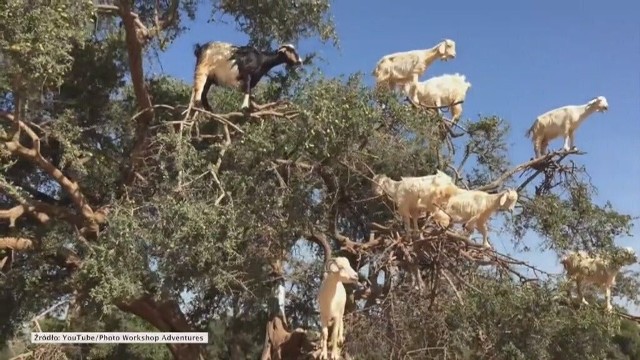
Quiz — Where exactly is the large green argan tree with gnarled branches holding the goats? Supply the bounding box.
[0,0,638,359]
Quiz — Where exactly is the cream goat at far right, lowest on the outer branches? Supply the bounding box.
[560,247,638,311]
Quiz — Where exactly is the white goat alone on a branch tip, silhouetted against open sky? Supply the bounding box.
[525,96,609,158]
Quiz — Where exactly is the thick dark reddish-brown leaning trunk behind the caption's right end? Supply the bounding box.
[117,296,204,360]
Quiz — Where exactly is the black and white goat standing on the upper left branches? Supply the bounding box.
[192,41,302,111]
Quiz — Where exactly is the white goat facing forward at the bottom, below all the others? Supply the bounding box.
[318,257,358,360]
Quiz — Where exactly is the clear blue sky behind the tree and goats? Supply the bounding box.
[154,0,640,306]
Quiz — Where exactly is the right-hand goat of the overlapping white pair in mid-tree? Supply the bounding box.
[433,188,518,248]
